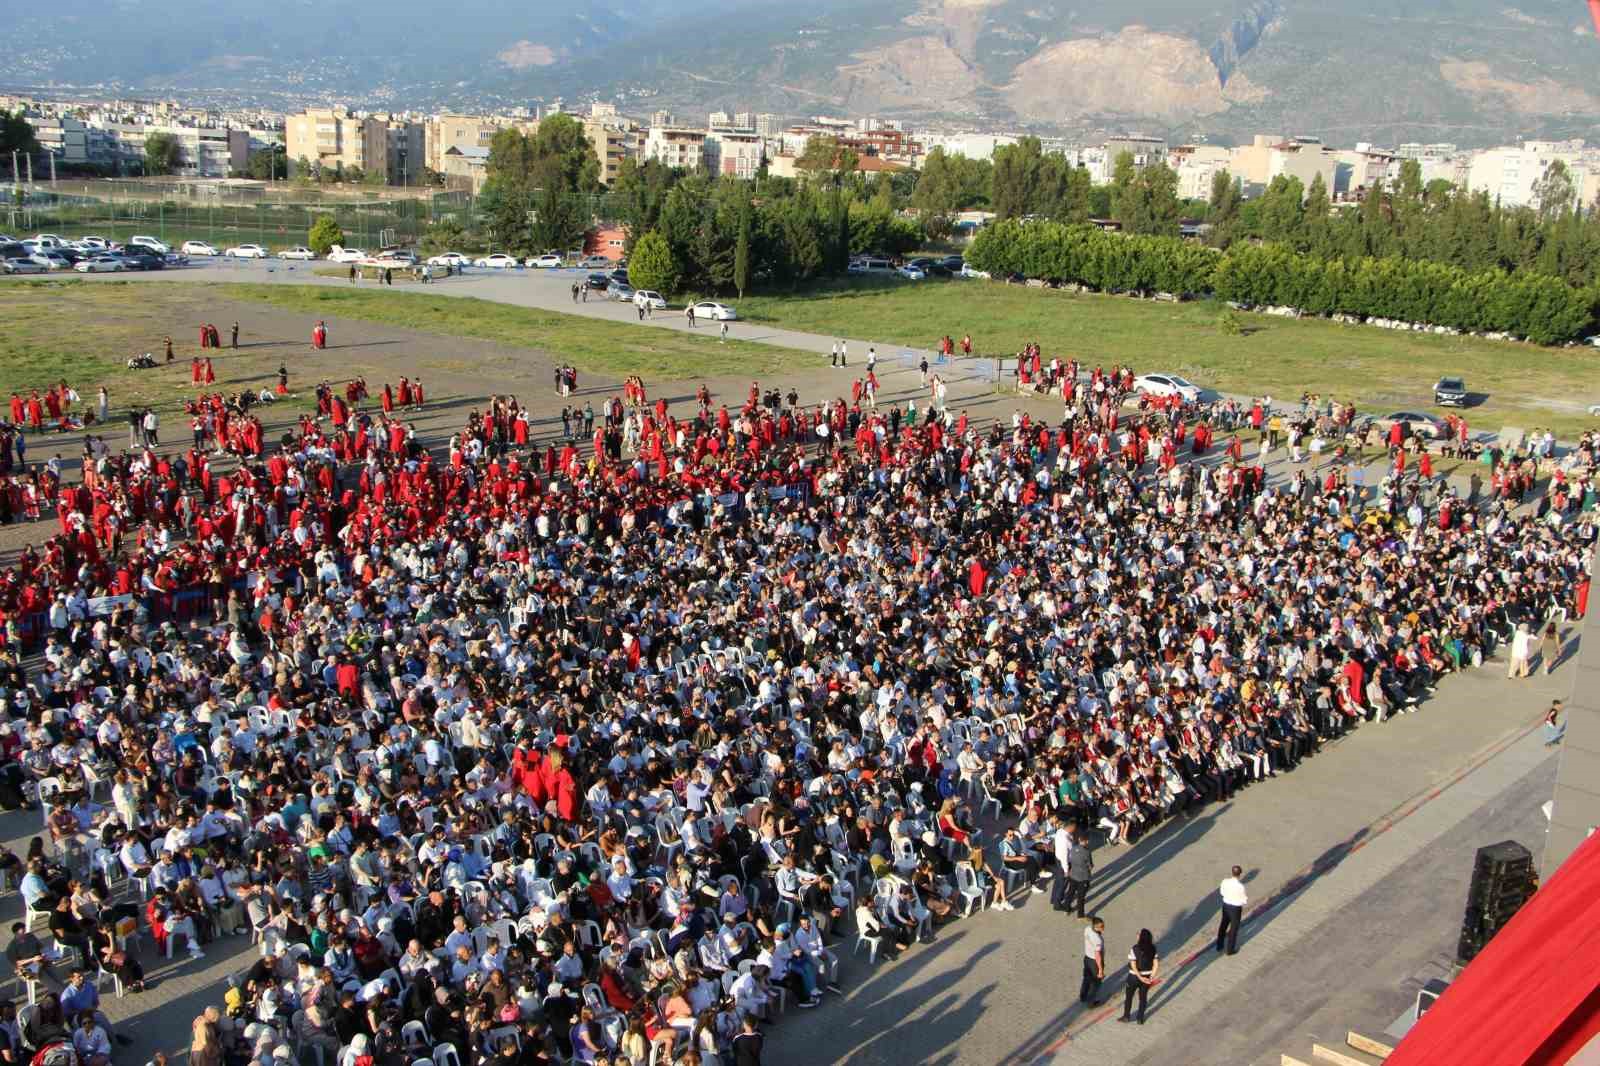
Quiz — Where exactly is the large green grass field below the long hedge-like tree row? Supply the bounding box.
[738,279,1600,439]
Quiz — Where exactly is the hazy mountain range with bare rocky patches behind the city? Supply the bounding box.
[9,0,1600,146]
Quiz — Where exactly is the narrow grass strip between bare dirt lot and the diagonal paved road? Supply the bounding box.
[209,285,813,381]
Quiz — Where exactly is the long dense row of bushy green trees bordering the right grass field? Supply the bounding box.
[966,219,1600,344]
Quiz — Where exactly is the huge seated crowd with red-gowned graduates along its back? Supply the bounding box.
[0,342,1597,1066]
